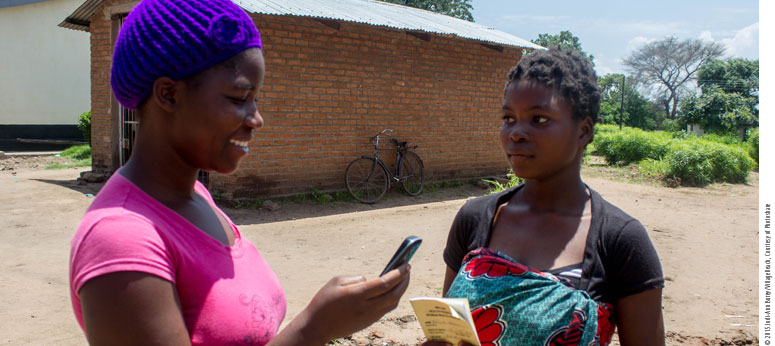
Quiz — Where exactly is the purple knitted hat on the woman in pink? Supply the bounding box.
[110,0,261,109]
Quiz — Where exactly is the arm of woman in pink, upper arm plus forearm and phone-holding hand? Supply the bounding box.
[78,264,409,346]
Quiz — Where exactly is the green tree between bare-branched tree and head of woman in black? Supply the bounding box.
[597,73,661,130]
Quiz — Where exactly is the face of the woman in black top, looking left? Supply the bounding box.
[500,80,589,180]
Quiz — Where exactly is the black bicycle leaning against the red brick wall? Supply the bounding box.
[344,129,424,204]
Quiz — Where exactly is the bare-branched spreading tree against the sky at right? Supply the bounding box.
[623,37,724,119]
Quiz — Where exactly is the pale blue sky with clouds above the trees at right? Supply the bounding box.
[471,0,759,75]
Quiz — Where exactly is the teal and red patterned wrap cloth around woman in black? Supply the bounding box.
[447,248,615,346]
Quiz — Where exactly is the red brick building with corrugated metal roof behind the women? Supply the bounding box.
[60,0,540,198]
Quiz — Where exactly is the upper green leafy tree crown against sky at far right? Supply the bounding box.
[697,58,759,115]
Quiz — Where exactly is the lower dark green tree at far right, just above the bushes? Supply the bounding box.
[679,85,759,134]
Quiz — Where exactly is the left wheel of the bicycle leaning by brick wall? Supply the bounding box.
[344,157,390,204]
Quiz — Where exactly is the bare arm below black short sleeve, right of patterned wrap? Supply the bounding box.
[616,288,665,346]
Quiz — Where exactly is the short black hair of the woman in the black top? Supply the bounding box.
[504,46,600,123]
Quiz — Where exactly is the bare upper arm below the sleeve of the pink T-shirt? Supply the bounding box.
[78,272,191,346]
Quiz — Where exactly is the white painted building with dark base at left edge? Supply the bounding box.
[0,0,91,150]
